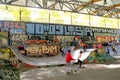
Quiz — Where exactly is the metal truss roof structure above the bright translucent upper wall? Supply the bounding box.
[0,0,120,19]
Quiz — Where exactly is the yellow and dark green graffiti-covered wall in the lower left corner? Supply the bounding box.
[0,46,20,80]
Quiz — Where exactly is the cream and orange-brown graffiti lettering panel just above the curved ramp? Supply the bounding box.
[25,46,59,56]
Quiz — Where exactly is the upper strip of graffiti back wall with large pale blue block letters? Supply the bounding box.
[0,21,119,41]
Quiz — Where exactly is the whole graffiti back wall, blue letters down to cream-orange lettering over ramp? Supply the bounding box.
[0,21,118,55]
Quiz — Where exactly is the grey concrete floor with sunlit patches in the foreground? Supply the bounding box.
[21,61,120,80]
